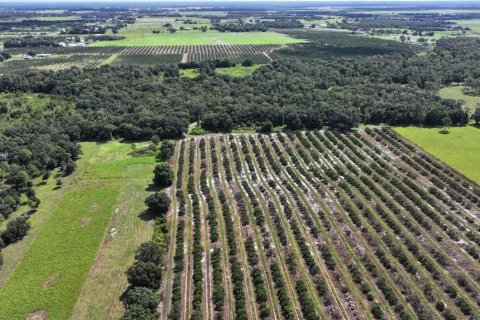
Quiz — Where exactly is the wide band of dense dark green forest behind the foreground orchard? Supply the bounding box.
[0,33,480,222]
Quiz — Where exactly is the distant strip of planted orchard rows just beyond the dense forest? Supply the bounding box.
[0,44,285,74]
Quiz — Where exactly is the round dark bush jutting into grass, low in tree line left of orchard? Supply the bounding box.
[126,261,162,290]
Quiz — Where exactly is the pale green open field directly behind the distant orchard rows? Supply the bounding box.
[91,27,302,47]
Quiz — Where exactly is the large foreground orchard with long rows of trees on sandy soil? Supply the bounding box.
[160,129,480,319]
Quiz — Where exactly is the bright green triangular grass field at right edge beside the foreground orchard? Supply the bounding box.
[395,126,480,184]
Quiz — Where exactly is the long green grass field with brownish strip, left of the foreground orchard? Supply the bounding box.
[0,142,155,319]
